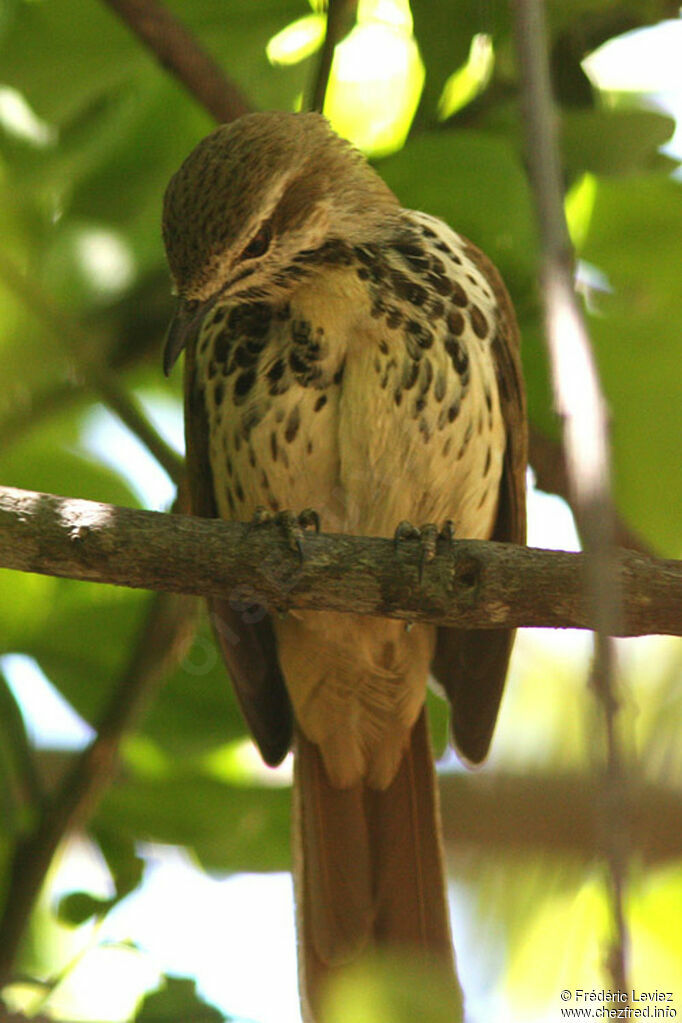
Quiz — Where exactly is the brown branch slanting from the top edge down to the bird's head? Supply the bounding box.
[103,0,252,124]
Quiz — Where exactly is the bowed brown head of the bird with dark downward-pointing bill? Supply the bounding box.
[164,113,400,370]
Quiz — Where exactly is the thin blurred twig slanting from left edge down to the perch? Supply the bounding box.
[0,253,185,485]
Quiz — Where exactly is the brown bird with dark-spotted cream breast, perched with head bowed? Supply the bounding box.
[163,112,528,1021]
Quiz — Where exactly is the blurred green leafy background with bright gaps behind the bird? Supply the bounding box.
[0,0,682,1020]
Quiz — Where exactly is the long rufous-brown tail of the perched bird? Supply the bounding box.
[293,710,456,1023]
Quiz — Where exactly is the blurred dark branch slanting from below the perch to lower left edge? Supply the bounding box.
[0,593,192,988]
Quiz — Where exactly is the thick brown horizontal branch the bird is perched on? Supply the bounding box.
[0,488,682,635]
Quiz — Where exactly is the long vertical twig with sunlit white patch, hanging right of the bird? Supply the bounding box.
[512,0,629,990]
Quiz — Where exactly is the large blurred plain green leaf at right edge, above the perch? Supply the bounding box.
[580,177,682,557]
